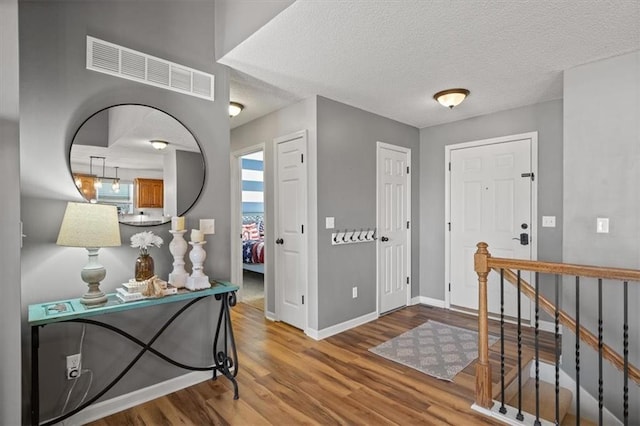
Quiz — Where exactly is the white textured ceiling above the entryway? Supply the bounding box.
[220,0,640,128]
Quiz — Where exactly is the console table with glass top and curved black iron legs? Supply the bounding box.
[29,281,238,425]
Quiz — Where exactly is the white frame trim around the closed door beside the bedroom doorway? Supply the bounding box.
[269,129,308,334]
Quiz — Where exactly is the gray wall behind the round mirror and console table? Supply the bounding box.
[14,1,230,418]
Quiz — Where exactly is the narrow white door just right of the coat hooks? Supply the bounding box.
[377,142,411,313]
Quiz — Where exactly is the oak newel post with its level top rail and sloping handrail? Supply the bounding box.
[474,242,640,409]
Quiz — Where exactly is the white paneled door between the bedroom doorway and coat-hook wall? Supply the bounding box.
[275,134,307,330]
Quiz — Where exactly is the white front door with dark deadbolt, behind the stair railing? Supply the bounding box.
[449,138,533,319]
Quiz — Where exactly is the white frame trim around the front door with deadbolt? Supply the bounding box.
[443,132,538,321]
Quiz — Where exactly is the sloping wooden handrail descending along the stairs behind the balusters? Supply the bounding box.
[500,268,640,386]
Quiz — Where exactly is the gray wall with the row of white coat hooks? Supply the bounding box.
[318,97,420,330]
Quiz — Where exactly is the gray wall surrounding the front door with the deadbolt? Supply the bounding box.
[420,100,563,300]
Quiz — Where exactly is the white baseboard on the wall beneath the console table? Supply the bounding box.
[58,371,211,426]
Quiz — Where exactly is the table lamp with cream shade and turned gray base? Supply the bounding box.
[56,202,121,308]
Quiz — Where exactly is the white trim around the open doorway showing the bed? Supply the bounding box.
[230,142,271,314]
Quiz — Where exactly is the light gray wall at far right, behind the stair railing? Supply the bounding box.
[562,51,640,424]
